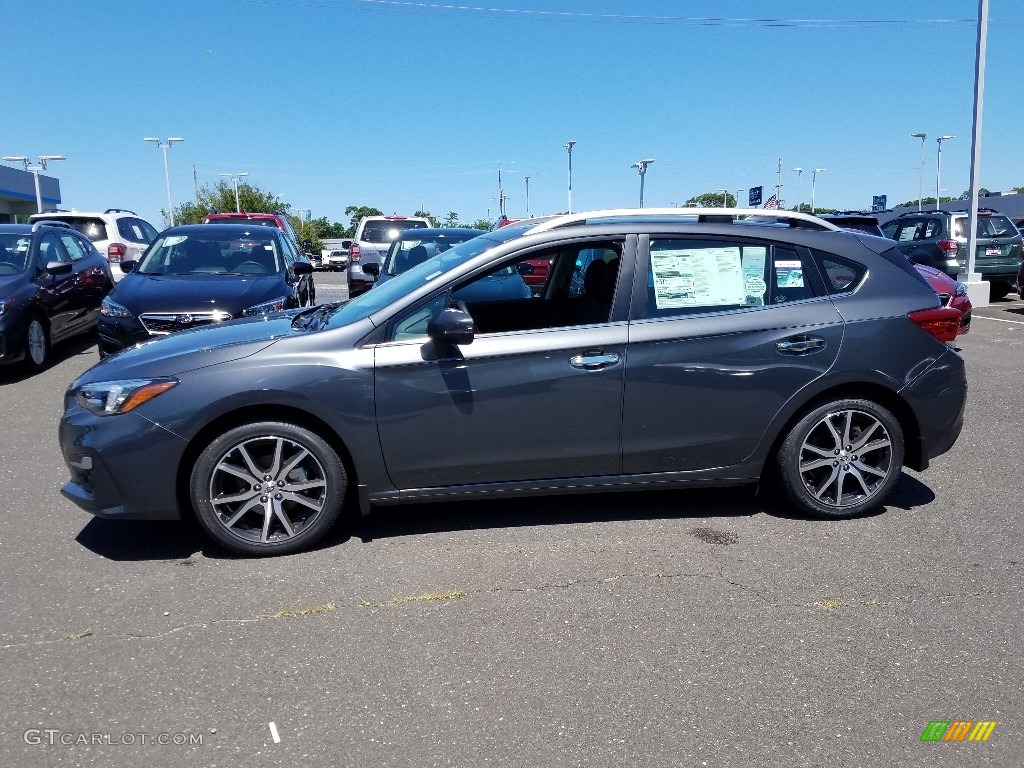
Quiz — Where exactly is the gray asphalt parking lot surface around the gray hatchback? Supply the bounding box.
[0,290,1024,767]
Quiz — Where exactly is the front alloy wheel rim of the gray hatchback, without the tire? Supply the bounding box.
[209,435,328,545]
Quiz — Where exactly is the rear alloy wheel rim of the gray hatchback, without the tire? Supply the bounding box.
[799,410,893,508]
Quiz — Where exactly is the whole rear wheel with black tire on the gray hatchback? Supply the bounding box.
[776,399,903,518]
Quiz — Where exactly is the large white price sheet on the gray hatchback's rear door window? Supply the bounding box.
[650,247,746,309]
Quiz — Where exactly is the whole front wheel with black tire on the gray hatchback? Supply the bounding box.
[189,422,348,557]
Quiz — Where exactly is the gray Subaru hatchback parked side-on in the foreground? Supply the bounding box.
[59,209,967,555]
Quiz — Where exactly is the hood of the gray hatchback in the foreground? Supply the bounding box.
[75,309,304,386]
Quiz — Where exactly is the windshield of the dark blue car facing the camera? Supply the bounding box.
[135,227,283,274]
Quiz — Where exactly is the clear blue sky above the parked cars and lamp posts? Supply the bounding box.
[0,0,1024,225]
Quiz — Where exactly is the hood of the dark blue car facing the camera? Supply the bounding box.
[111,272,289,317]
